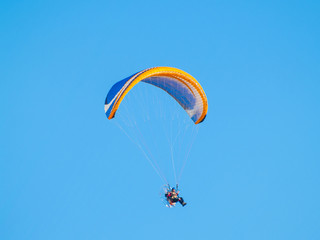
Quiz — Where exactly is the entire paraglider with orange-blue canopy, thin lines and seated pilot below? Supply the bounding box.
[104,67,208,207]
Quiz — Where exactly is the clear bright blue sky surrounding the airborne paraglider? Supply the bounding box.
[0,0,320,240]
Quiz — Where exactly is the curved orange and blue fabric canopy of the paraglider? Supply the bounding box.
[105,67,208,124]
